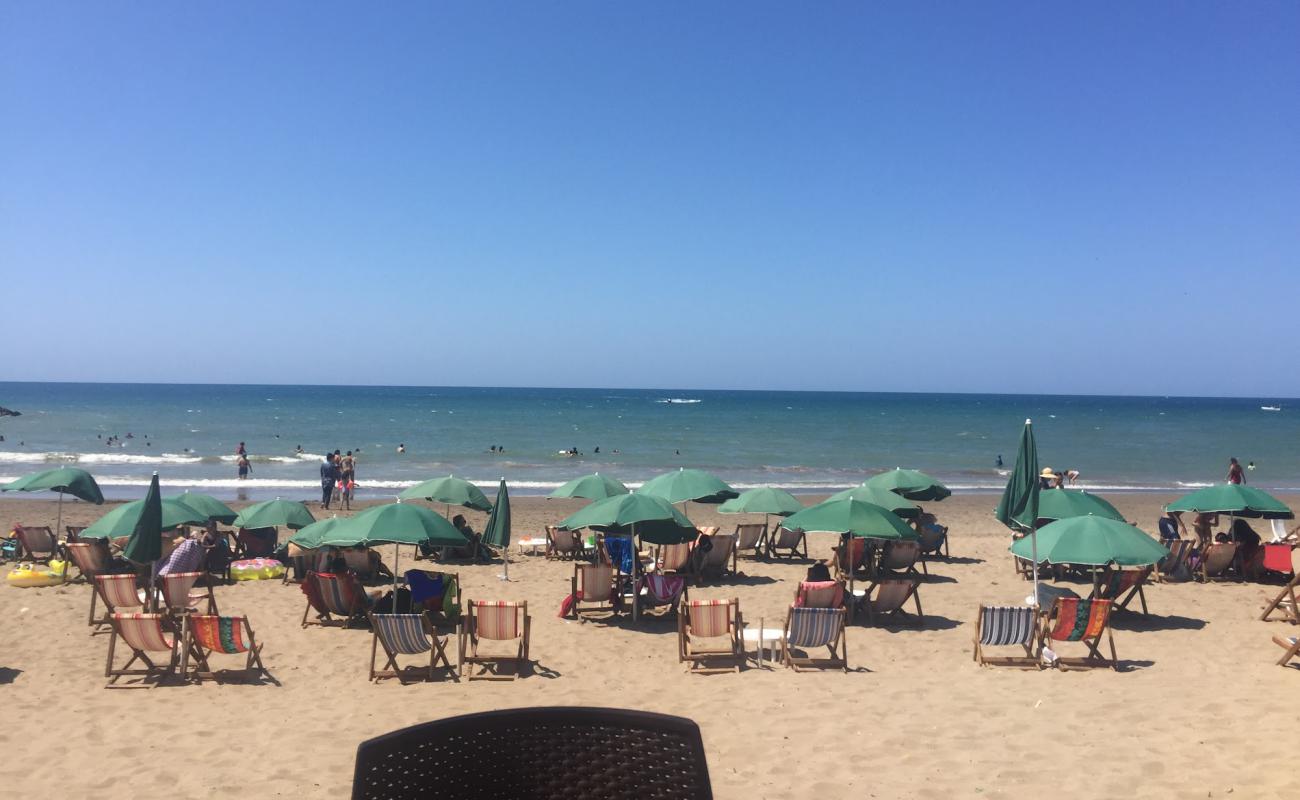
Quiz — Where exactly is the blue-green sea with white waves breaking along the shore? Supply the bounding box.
[0,382,1300,500]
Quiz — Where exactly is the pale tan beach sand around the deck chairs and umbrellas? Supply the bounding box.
[0,494,1300,799]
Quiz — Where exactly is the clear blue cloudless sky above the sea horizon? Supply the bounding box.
[0,0,1300,397]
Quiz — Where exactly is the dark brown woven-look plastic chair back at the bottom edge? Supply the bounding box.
[352,706,712,800]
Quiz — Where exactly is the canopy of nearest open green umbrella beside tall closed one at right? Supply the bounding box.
[1011,516,1169,567]
